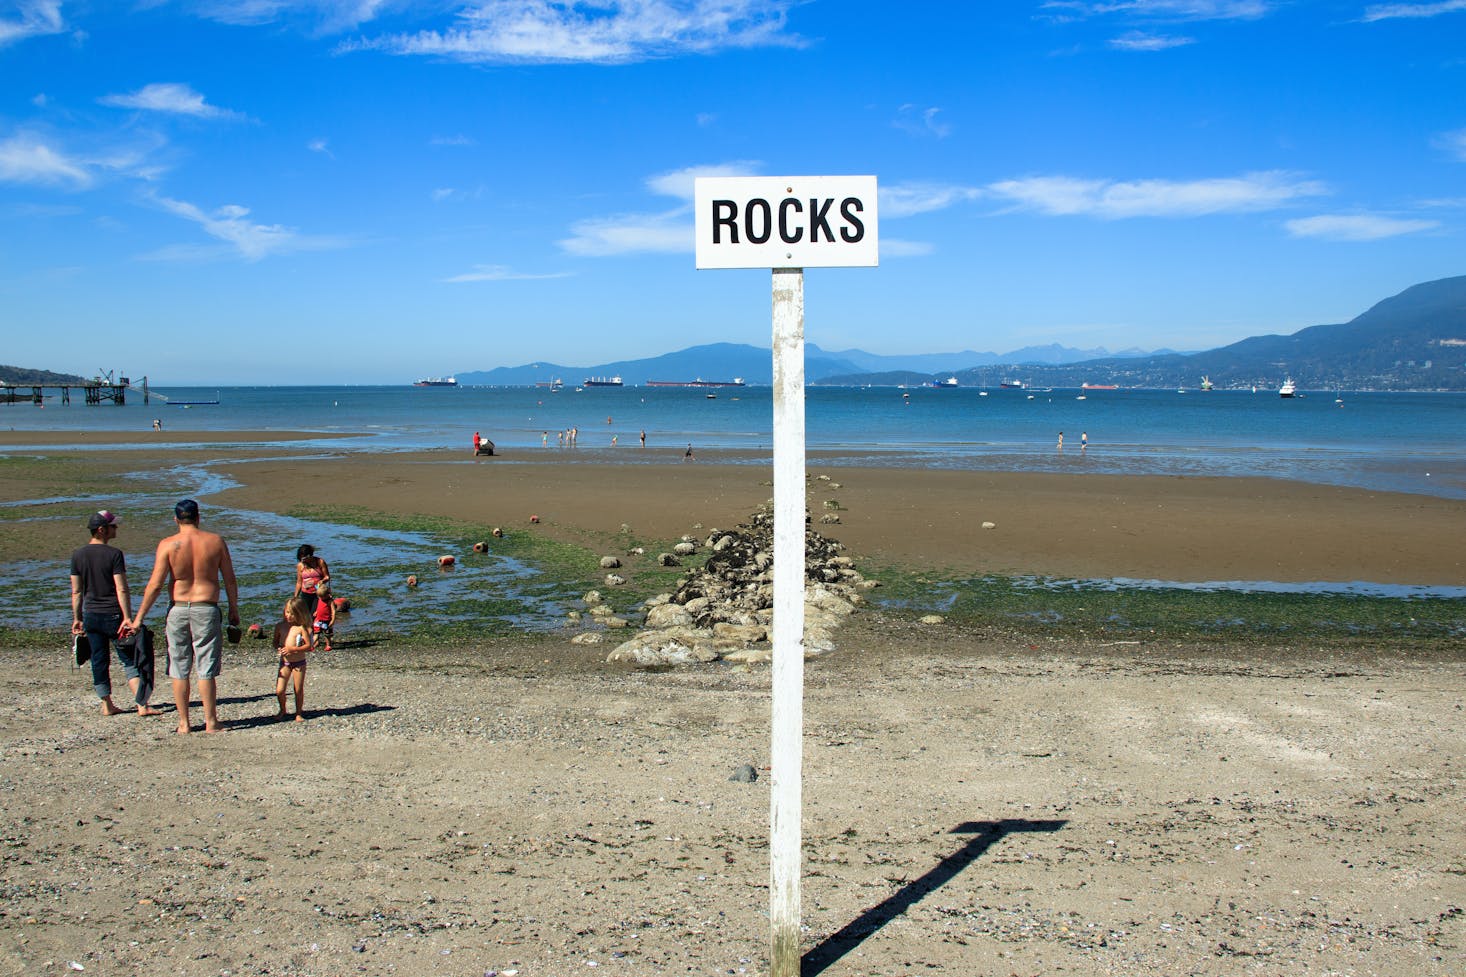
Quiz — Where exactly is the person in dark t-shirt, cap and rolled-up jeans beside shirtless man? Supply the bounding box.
[72,509,160,716]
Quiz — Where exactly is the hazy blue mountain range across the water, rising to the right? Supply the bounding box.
[456,276,1466,390]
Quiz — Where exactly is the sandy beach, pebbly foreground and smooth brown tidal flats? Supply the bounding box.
[0,442,1466,977]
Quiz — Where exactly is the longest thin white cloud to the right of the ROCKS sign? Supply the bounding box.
[987,172,1328,220]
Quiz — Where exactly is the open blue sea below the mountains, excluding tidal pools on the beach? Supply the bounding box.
[0,386,1466,499]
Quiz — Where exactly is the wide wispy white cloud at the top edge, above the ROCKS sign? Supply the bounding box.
[343,0,803,65]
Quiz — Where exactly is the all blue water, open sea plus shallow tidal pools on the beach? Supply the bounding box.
[0,387,1466,624]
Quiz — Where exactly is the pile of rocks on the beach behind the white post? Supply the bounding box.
[607,508,878,665]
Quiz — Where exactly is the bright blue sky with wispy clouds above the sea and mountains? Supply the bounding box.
[0,0,1466,384]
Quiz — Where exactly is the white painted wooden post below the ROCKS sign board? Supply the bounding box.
[768,262,805,977]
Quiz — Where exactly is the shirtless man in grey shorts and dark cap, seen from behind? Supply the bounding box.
[133,499,239,733]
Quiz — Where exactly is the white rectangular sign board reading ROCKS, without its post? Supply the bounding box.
[693,176,880,268]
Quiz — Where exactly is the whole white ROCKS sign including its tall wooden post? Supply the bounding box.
[693,176,878,977]
